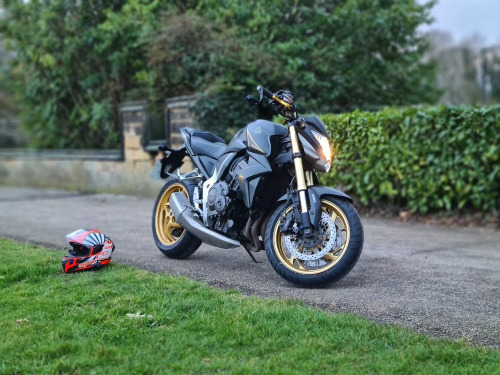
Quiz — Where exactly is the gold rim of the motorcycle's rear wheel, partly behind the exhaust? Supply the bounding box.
[155,184,189,246]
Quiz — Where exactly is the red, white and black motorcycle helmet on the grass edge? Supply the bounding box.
[62,229,115,272]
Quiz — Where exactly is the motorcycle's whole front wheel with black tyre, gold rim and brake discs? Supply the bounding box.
[265,196,364,287]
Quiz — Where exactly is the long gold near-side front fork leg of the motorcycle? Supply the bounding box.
[288,125,313,237]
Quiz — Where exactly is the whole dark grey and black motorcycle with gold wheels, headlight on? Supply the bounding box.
[153,86,363,287]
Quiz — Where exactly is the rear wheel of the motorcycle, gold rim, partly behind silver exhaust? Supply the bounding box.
[152,179,201,259]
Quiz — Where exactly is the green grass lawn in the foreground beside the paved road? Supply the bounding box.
[0,238,500,375]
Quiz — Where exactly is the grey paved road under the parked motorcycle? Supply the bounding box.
[0,186,500,348]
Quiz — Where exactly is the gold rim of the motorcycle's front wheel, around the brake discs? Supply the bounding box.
[273,200,351,275]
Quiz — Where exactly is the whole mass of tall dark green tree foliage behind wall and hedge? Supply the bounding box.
[0,0,438,148]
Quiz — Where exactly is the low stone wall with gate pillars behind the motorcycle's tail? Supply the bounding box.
[0,101,198,196]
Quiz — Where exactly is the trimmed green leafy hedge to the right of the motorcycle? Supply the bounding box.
[322,106,500,213]
